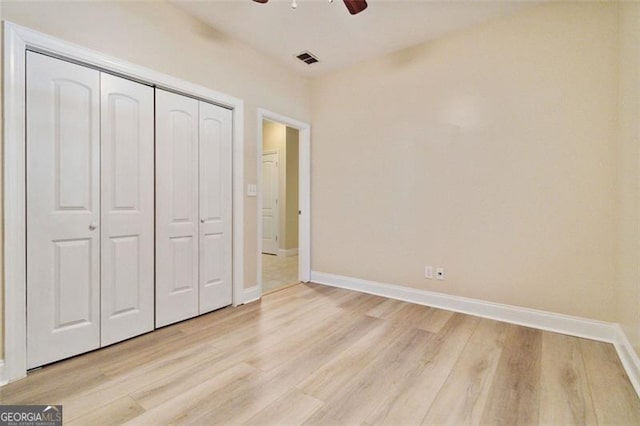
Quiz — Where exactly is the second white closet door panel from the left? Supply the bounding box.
[101,73,154,346]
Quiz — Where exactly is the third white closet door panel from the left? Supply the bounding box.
[156,89,199,327]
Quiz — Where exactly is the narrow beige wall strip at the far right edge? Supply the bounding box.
[616,3,640,355]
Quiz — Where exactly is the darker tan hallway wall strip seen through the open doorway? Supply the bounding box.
[284,127,300,249]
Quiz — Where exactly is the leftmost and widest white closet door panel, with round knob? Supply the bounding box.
[26,52,100,368]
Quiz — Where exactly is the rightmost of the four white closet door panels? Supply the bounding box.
[199,102,232,314]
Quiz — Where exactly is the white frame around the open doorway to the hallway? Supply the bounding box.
[256,108,311,297]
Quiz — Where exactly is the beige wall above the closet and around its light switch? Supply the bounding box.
[0,1,310,356]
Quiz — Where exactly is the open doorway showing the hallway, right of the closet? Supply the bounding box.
[260,119,300,294]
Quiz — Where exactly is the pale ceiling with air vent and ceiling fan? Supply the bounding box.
[171,0,533,77]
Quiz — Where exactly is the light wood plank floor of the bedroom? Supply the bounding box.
[0,284,640,425]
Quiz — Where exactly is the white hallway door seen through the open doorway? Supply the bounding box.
[262,152,279,254]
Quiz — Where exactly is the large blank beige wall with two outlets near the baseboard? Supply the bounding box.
[311,3,617,321]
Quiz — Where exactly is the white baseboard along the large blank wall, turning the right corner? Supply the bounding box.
[311,271,640,396]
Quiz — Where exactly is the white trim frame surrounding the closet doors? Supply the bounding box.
[0,21,244,384]
